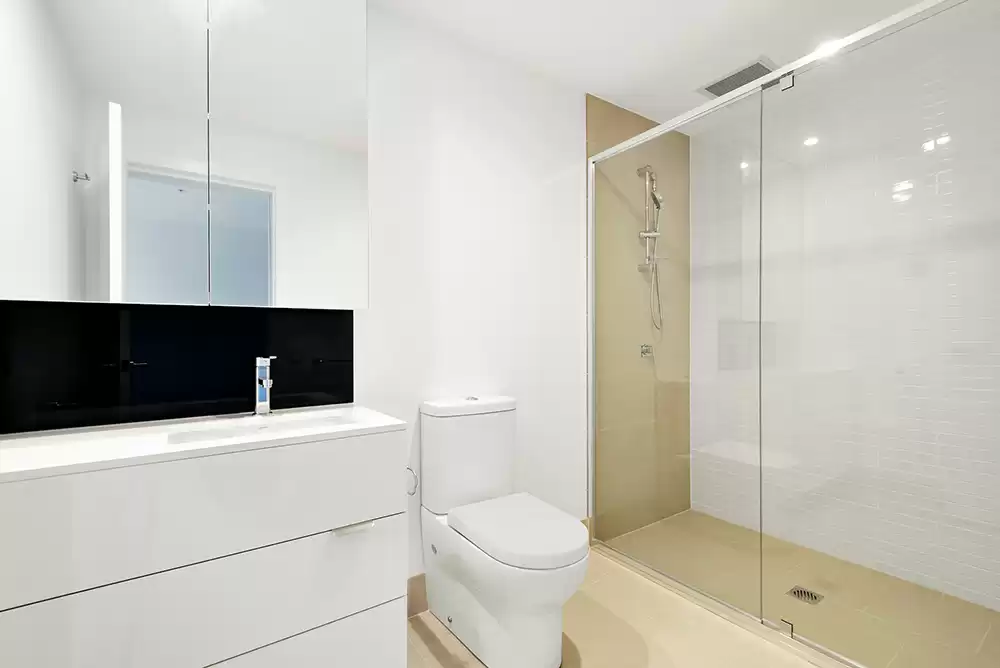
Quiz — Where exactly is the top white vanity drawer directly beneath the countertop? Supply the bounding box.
[0,431,407,610]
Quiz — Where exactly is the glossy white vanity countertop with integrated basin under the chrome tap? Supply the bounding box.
[0,406,406,484]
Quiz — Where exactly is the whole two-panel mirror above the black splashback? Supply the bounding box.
[0,0,368,309]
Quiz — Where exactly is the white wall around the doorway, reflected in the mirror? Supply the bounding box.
[124,111,368,309]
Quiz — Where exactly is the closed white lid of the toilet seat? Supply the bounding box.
[448,494,589,569]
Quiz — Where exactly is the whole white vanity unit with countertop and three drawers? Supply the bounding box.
[0,407,407,668]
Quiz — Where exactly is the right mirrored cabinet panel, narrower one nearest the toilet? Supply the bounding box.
[210,0,368,309]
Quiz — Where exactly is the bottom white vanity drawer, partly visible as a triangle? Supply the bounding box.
[219,598,406,668]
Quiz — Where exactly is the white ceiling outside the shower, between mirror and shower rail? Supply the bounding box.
[370,0,914,122]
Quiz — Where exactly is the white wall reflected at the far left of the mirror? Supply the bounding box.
[0,0,83,300]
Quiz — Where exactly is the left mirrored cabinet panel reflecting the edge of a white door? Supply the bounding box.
[0,0,208,303]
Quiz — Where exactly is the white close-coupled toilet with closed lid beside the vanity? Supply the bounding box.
[420,397,590,668]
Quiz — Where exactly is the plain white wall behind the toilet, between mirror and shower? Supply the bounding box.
[355,7,587,573]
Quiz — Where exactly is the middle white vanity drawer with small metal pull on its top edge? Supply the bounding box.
[0,515,407,668]
